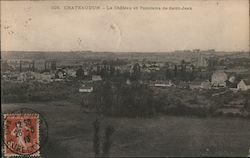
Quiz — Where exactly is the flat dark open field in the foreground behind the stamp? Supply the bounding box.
[2,101,250,158]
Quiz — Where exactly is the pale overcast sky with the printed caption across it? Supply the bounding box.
[1,0,249,52]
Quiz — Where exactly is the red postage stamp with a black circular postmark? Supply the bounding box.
[4,114,40,157]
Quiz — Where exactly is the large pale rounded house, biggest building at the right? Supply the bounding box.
[211,71,228,87]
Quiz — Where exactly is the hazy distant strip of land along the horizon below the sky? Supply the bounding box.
[1,51,249,62]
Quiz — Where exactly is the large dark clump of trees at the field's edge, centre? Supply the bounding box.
[94,82,154,117]
